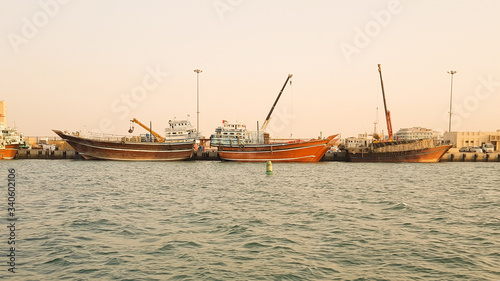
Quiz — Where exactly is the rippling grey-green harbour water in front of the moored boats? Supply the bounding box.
[0,160,500,280]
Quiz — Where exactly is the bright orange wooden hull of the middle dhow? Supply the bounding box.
[219,135,337,162]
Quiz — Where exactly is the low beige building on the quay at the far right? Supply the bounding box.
[444,130,500,151]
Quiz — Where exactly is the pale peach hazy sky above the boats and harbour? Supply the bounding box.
[0,0,500,138]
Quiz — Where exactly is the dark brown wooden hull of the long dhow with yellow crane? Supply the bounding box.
[54,130,194,161]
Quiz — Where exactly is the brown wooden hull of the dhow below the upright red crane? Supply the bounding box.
[347,145,452,163]
